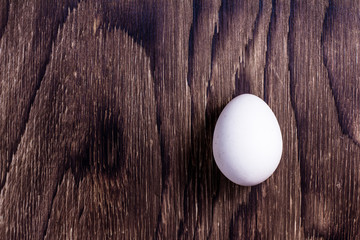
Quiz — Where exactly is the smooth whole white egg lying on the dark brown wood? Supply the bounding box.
[213,94,283,186]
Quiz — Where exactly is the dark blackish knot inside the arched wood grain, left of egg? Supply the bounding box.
[70,111,125,183]
